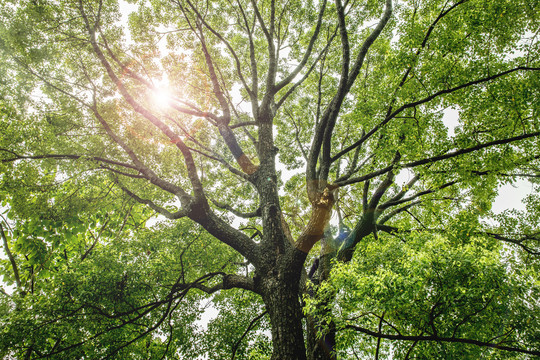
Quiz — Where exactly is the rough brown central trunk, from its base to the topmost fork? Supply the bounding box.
[252,112,307,360]
